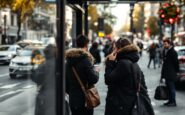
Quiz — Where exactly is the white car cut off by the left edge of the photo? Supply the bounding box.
[0,45,21,64]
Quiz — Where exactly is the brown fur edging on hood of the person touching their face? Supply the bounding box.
[118,44,139,53]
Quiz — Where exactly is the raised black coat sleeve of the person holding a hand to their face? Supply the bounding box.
[105,61,131,85]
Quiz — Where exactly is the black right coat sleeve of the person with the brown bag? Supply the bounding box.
[83,59,99,84]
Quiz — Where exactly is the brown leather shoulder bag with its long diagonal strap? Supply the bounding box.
[72,67,100,109]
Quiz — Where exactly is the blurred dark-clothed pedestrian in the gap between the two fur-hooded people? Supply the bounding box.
[89,42,101,64]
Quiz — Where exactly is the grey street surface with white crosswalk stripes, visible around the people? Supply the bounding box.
[0,53,185,115]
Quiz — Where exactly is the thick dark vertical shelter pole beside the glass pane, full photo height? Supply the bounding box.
[56,0,66,115]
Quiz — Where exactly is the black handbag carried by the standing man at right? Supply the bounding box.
[154,84,169,100]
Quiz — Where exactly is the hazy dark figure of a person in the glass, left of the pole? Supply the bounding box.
[31,45,56,115]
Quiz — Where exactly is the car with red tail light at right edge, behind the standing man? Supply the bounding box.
[175,46,185,85]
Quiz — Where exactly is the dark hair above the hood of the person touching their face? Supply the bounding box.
[115,38,131,49]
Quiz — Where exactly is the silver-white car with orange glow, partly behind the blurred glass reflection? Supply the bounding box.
[9,46,45,79]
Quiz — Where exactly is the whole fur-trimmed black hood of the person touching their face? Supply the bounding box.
[116,44,139,62]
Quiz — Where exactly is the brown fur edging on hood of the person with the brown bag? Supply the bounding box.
[65,48,94,63]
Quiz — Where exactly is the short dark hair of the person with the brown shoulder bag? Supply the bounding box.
[76,35,89,48]
